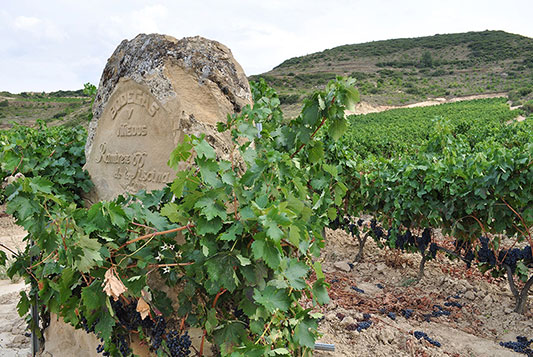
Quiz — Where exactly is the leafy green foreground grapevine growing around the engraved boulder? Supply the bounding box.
[1,78,358,356]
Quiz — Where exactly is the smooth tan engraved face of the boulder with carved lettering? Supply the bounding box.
[86,80,175,199]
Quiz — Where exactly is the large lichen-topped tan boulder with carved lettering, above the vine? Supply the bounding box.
[85,34,251,202]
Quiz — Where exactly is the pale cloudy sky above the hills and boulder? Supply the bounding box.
[0,0,533,93]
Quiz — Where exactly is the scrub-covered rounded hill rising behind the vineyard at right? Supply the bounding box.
[250,31,533,111]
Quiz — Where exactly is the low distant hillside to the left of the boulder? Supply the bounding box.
[0,90,91,129]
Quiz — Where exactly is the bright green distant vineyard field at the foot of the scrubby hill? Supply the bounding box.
[343,98,530,157]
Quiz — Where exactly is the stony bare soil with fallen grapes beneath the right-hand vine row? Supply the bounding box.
[315,230,533,357]
